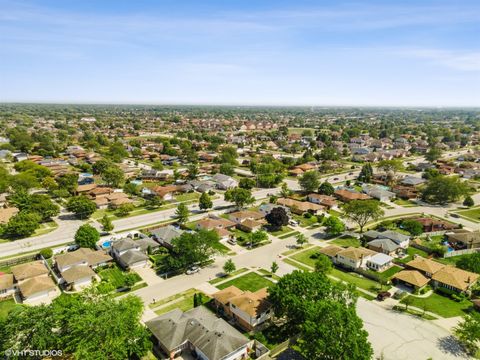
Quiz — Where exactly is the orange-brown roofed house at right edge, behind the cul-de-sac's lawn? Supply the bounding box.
[432,265,480,293]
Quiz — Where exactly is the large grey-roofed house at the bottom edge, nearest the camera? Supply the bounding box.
[145,306,253,360]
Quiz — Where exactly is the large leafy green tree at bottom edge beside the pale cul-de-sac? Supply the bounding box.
[297,300,373,360]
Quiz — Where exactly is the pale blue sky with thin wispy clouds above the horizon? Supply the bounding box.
[0,0,480,106]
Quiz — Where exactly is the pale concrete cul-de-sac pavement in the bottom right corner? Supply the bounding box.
[357,298,469,360]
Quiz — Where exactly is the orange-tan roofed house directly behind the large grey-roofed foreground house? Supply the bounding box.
[213,285,271,331]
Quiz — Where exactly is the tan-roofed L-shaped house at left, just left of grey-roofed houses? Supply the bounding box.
[54,248,113,289]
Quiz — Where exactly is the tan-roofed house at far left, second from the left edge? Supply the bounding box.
[11,260,59,303]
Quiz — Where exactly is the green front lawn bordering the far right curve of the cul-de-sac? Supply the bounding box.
[401,293,472,317]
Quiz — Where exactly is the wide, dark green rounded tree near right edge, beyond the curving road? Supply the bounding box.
[422,176,469,205]
